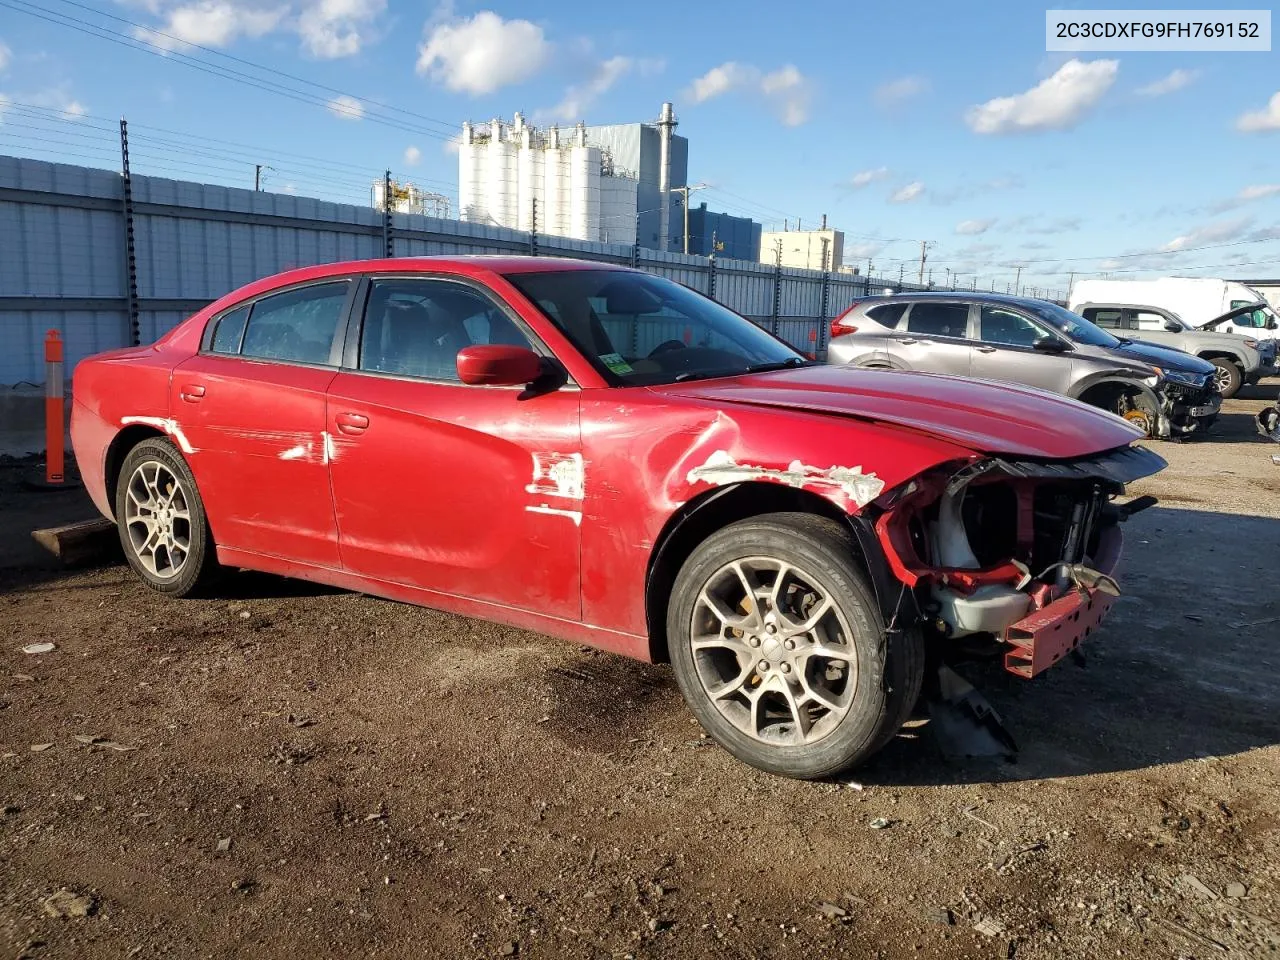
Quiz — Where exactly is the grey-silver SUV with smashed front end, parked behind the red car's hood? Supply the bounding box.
[827,293,1222,438]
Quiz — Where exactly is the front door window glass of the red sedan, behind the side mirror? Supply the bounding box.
[360,279,530,380]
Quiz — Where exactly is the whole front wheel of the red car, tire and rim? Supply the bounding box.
[667,513,924,780]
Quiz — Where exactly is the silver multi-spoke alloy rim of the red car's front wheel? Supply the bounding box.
[690,557,858,746]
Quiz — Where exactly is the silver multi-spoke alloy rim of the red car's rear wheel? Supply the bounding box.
[124,460,191,580]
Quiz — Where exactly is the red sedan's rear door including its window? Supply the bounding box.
[169,278,356,568]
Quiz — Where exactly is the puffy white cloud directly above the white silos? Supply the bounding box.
[417,10,552,96]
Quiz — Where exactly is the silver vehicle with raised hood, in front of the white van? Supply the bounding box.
[1075,303,1276,399]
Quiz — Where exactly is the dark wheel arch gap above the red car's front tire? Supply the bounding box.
[645,481,897,663]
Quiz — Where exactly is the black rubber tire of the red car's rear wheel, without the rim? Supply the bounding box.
[115,438,221,596]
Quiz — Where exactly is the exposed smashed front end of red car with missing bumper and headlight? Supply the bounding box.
[863,447,1166,753]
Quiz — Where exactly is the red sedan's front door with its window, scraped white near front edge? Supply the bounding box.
[328,274,584,620]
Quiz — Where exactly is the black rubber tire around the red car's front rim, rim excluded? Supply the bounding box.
[667,513,924,780]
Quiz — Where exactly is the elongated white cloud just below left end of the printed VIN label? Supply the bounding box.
[965,60,1120,134]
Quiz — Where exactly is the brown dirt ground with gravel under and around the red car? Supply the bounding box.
[0,381,1280,960]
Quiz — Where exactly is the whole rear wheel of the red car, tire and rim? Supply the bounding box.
[115,438,219,596]
